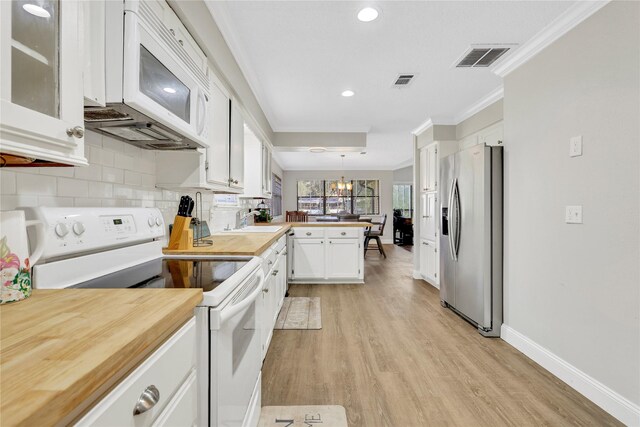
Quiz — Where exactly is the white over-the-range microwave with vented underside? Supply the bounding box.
[85,0,210,150]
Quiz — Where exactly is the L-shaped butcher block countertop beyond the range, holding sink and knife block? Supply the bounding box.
[162,222,371,256]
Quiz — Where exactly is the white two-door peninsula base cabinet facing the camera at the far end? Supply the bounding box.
[288,227,364,283]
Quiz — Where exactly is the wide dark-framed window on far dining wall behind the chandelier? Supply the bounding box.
[298,179,380,215]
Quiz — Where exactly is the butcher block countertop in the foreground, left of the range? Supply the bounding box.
[0,289,202,426]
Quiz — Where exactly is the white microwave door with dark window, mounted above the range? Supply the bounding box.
[122,8,208,146]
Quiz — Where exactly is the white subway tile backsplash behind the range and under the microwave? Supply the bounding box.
[0,132,218,237]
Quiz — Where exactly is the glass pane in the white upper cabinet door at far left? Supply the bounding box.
[11,0,60,118]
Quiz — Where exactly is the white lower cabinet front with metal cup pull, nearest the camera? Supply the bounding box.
[76,318,198,427]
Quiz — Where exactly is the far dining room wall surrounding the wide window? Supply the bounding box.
[282,170,393,243]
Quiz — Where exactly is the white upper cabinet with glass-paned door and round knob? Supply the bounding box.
[0,0,87,165]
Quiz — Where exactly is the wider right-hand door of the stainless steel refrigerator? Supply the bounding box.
[454,145,491,325]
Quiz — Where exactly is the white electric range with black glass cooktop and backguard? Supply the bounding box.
[24,207,264,426]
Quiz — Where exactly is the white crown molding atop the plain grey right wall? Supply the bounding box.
[492,0,610,78]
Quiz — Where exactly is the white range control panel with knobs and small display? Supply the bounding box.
[24,207,165,260]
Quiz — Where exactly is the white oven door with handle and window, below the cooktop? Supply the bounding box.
[210,269,264,427]
